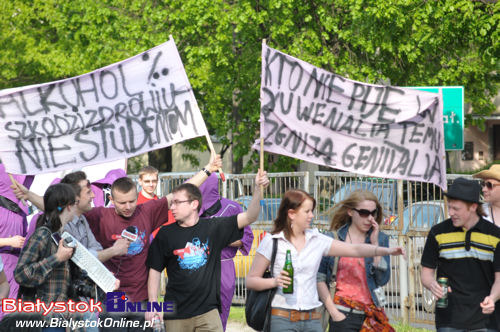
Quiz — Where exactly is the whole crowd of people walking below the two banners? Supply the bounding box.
[0,156,500,332]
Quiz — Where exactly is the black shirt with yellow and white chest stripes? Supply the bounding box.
[422,218,500,329]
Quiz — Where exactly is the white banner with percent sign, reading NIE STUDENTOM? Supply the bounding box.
[0,39,207,174]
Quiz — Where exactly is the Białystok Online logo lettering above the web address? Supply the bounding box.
[2,292,175,316]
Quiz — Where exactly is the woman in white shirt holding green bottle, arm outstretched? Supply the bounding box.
[246,189,404,332]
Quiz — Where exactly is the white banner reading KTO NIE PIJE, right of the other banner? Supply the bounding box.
[253,44,446,189]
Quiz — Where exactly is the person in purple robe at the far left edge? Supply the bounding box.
[0,164,33,304]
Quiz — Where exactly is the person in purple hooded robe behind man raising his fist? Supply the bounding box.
[200,173,253,331]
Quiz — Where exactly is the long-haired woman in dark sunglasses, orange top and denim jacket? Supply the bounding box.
[318,190,394,332]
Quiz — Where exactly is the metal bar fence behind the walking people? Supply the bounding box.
[144,172,467,324]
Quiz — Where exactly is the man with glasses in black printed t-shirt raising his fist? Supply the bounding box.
[146,171,269,332]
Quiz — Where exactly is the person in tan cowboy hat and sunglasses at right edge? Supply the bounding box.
[472,164,500,226]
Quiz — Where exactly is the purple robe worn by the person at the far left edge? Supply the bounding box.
[0,164,33,304]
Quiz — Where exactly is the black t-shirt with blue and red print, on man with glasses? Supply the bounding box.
[146,215,243,319]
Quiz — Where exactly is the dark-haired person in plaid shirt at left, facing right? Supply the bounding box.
[14,183,77,331]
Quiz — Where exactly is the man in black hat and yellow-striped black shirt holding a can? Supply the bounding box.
[421,178,500,332]
